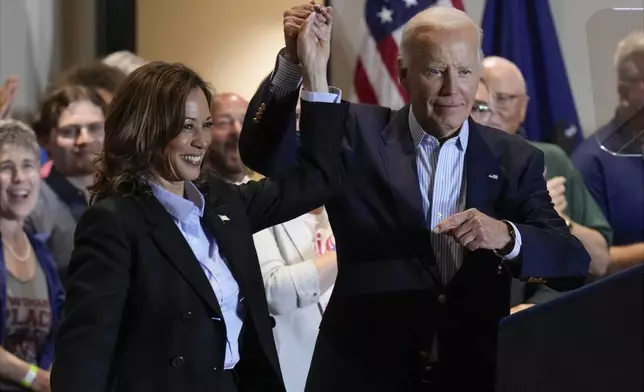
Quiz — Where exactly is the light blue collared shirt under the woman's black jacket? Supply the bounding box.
[151,181,243,369]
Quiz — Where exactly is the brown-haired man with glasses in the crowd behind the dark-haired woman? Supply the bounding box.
[26,86,106,281]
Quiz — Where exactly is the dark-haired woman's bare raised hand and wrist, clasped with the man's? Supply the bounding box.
[297,7,332,91]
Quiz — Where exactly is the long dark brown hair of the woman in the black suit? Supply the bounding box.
[89,62,212,203]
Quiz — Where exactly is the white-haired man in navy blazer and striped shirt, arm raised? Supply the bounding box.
[240,7,589,392]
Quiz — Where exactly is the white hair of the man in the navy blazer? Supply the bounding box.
[399,6,484,64]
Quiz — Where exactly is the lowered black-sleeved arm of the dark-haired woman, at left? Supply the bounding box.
[51,206,130,392]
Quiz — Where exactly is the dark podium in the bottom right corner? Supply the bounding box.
[497,266,644,392]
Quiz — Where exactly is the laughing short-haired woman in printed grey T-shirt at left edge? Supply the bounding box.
[0,120,63,392]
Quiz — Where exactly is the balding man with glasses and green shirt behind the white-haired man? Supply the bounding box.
[480,57,612,304]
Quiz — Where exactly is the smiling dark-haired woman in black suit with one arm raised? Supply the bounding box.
[52,62,348,392]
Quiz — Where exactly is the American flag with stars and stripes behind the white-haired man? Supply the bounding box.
[354,0,464,109]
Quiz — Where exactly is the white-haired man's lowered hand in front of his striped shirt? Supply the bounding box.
[434,208,512,251]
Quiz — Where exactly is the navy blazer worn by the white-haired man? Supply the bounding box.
[239,80,590,392]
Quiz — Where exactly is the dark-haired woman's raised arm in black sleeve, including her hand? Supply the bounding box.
[237,12,350,232]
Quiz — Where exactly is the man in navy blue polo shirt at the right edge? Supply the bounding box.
[572,31,644,272]
